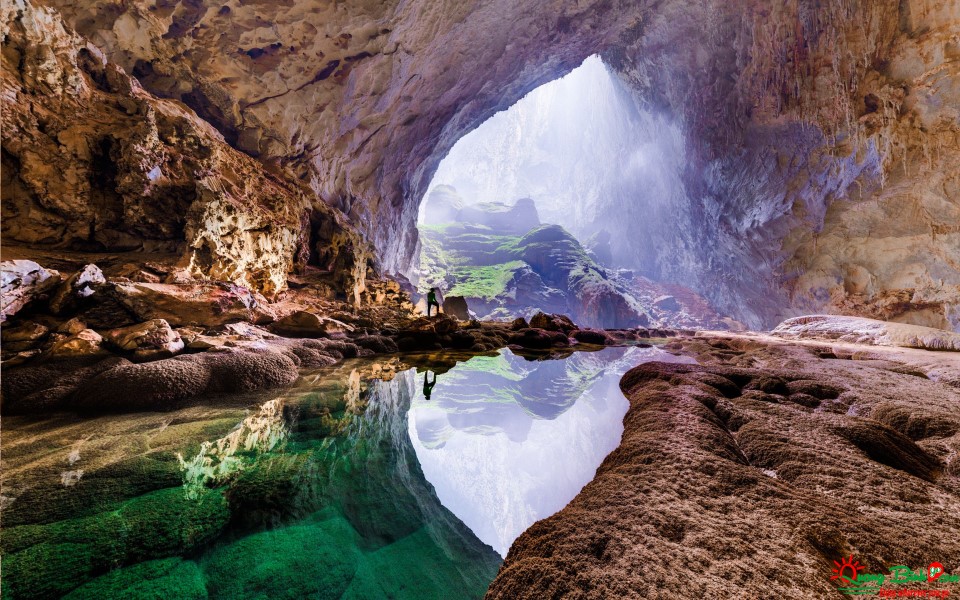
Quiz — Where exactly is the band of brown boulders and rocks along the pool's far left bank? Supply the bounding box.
[2,256,676,414]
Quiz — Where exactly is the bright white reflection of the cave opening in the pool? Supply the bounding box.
[409,348,689,556]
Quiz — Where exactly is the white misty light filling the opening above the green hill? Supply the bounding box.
[421,55,684,274]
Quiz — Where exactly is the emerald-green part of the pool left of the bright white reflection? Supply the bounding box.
[0,359,501,600]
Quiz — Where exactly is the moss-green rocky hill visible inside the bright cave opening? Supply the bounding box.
[420,186,649,328]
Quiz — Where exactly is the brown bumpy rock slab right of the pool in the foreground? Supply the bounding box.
[487,337,960,599]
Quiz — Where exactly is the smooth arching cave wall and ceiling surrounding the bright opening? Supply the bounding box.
[4,0,960,328]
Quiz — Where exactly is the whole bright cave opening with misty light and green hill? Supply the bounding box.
[418,55,736,328]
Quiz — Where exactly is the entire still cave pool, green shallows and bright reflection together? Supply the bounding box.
[0,348,683,599]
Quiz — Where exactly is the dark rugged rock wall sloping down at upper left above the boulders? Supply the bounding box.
[2,2,367,296]
